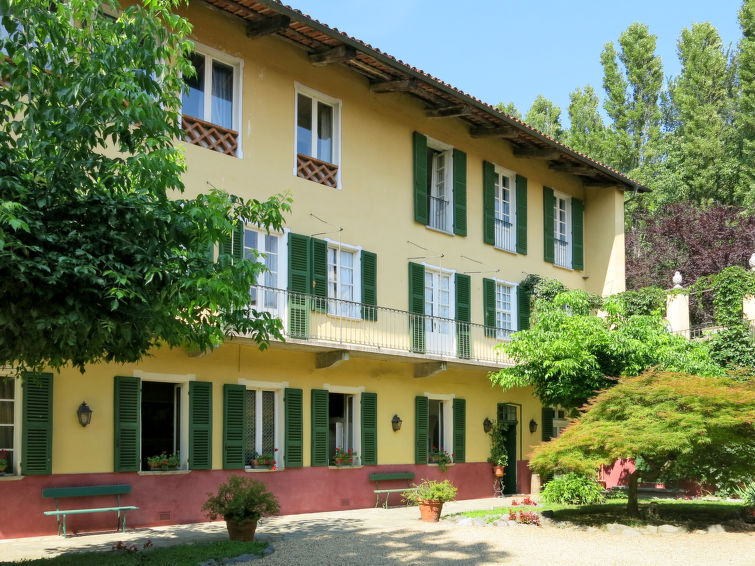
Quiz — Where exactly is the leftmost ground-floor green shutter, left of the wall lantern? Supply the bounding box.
[21,373,52,476]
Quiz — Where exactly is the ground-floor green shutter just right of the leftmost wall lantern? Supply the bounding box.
[113,376,142,472]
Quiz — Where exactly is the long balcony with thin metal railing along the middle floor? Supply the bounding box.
[245,286,513,368]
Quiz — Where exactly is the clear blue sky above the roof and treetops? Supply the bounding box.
[284,0,741,124]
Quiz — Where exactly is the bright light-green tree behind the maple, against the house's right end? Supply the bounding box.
[490,291,723,407]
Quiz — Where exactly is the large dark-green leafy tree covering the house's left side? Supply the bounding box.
[0,0,288,378]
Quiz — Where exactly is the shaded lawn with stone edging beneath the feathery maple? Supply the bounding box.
[454,499,742,530]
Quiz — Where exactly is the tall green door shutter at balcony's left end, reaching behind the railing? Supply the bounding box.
[288,233,312,339]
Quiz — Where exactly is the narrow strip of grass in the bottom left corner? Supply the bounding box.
[0,541,267,566]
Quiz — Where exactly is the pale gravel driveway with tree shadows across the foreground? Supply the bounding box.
[248,500,755,566]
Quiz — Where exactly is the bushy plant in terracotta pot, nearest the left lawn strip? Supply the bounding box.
[202,476,280,542]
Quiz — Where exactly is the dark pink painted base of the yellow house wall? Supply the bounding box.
[0,461,531,538]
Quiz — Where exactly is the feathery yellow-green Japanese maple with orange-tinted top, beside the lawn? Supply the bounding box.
[530,370,755,515]
